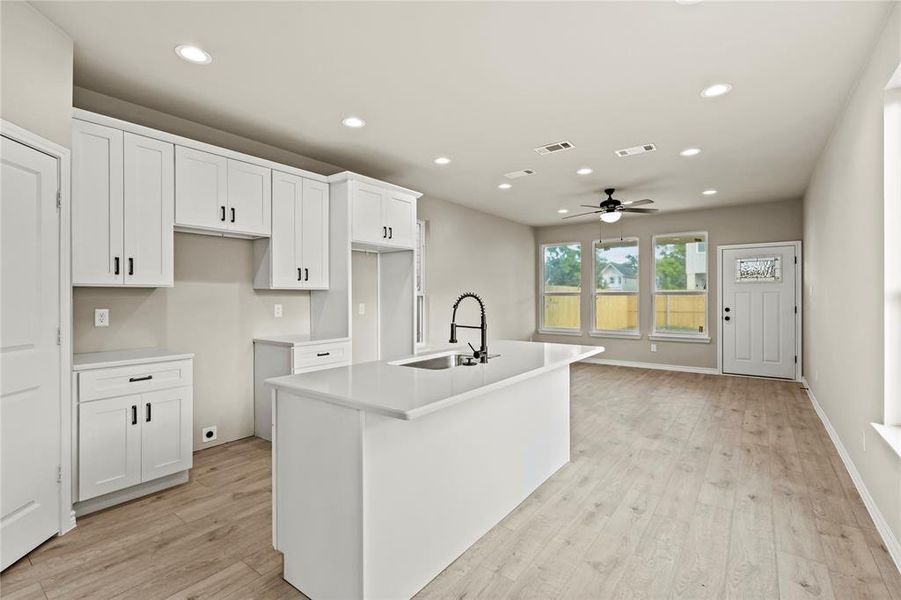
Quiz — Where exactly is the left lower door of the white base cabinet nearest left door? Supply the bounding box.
[78,396,141,501]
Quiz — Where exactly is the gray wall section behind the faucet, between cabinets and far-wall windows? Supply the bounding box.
[418,197,535,346]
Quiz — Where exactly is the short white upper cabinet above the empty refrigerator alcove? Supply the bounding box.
[351,182,416,248]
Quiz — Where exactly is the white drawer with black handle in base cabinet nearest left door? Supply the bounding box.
[78,360,194,402]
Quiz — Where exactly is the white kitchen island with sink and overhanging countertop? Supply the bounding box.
[267,341,603,600]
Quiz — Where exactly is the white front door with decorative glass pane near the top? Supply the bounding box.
[720,244,797,379]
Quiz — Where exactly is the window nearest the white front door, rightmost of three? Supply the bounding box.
[654,233,708,340]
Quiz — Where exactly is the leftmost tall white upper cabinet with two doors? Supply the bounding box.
[72,120,175,287]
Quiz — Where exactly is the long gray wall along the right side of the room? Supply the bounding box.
[804,5,901,538]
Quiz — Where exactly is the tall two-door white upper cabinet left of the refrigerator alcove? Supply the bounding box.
[254,171,329,290]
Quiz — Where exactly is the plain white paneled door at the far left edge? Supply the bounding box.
[0,138,61,569]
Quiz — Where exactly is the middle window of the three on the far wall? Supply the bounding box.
[592,238,639,335]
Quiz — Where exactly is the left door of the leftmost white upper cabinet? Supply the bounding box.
[72,120,124,285]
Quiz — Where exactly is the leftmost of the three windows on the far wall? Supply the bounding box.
[541,243,582,332]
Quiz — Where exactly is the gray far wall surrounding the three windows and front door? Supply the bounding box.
[533,200,802,368]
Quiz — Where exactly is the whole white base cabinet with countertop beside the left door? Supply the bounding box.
[73,348,193,514]
